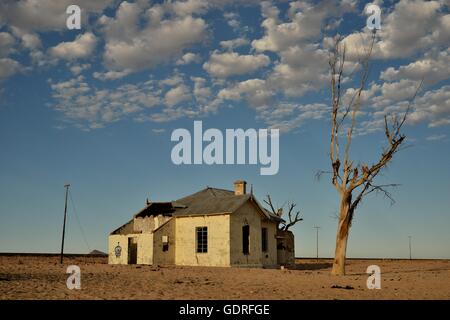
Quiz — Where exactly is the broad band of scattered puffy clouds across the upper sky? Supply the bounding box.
[0,0,450,136]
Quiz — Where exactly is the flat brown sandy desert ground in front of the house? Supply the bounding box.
[0,256,450,300]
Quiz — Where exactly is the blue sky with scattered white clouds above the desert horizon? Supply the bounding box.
[0,0,450,259]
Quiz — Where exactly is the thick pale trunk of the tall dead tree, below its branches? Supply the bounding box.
[331,193,352,276]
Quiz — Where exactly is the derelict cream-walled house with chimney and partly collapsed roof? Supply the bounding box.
[108,181,294,267]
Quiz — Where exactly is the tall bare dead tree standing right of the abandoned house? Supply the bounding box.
[329,35,420,275]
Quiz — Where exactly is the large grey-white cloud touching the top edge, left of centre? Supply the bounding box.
[100,2,207,71]
